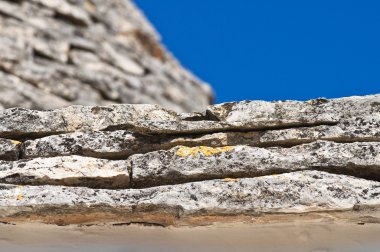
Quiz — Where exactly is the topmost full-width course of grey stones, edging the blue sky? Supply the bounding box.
[0,95,380,138]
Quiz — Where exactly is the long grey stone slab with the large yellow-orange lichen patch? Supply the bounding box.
[129,141,380,187]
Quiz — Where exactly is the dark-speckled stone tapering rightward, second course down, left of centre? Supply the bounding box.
[21,130,224,159]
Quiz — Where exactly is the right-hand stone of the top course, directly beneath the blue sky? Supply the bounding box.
[204,95,380,129]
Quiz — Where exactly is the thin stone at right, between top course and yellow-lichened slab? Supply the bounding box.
[221,114,380,147]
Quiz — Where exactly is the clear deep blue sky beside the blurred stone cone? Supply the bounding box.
[136,0,380,102]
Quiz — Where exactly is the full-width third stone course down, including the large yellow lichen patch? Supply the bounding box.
[0,140,380,188]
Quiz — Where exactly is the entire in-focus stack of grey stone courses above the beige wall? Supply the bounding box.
[0,95,380,224]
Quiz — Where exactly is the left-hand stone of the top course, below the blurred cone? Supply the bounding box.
[0,104,177,138]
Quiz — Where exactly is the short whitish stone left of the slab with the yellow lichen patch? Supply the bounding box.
[0,156,129,188]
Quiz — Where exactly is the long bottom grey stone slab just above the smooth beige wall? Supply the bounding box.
[0,171,380,218]
